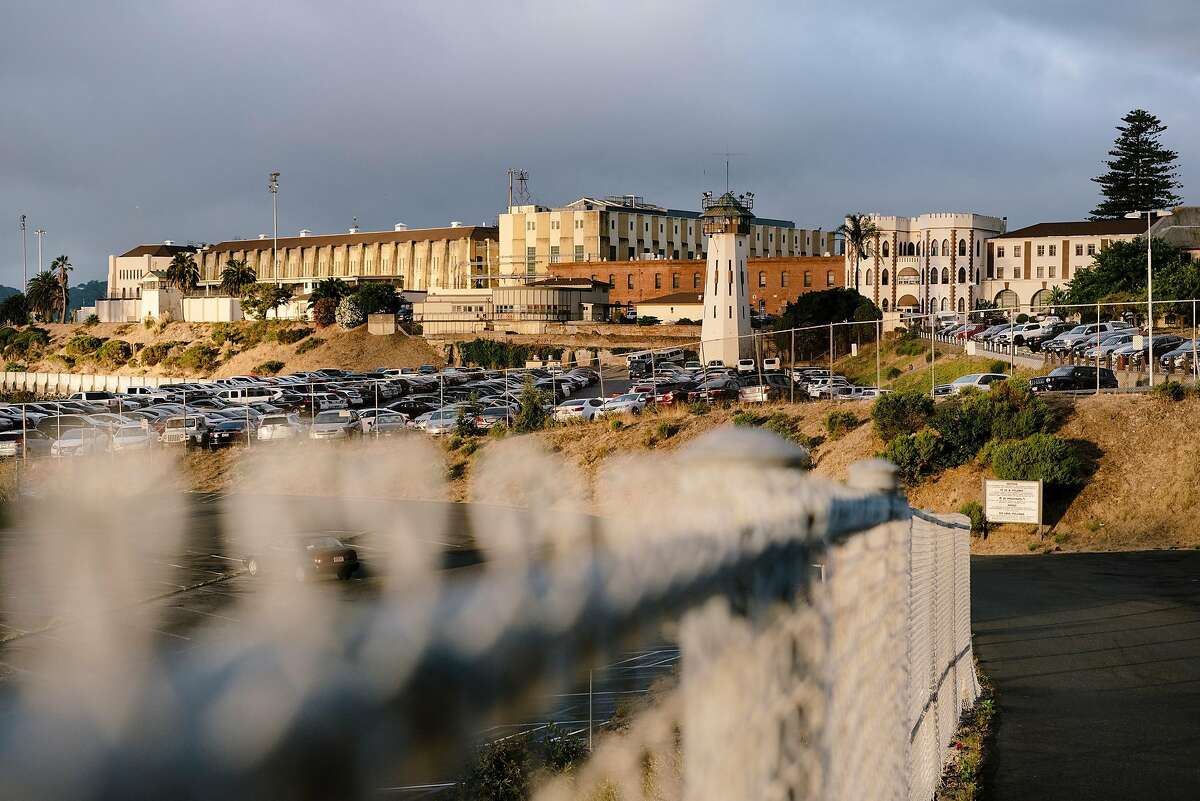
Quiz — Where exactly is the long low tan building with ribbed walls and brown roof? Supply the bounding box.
[197,224,499,291]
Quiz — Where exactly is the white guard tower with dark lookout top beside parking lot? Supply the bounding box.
[701,192,754,367]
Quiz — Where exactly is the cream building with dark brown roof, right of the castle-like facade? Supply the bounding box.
[983,219,1146,308]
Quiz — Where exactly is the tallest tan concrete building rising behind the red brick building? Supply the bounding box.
[499,195,836,283]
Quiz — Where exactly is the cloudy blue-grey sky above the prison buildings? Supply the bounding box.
[0,0,1200,285]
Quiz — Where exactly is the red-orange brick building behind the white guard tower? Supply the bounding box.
[550,255,846,314]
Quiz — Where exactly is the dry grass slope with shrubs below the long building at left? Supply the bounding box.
[4,321,444,378]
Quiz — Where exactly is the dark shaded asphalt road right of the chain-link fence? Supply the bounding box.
[971,552,1200,801]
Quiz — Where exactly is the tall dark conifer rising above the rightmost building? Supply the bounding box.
[1092,108,1183,219]
